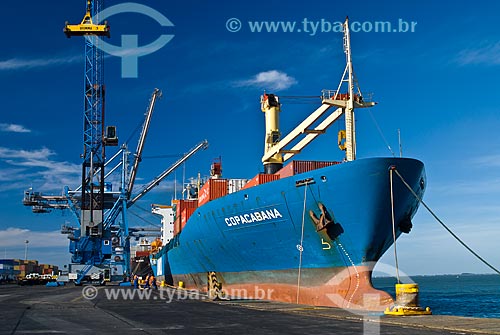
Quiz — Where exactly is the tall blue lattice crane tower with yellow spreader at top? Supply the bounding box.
[64,0,113,280]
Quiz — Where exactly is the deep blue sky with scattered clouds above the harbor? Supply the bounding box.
[0,0,500,274]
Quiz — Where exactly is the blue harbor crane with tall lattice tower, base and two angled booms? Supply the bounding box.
[23,0,208,284]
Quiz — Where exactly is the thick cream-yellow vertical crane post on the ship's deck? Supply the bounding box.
[260,93,283,174]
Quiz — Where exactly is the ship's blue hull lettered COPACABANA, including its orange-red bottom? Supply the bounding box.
[155,158,426,309]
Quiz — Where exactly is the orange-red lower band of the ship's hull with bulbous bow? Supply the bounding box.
[174,266,394,311]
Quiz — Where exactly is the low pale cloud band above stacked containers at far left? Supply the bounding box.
[0,227,68,248]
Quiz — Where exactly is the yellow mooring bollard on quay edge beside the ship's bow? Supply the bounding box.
[384,283,432,316]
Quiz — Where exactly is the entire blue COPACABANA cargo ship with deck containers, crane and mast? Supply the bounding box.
[151,19,426,310]
